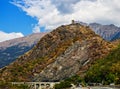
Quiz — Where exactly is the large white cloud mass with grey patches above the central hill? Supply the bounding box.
[12,0,120,32]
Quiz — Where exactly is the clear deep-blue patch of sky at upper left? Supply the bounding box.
[0,0,37,35]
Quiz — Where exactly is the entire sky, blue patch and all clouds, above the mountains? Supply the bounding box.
[0,0,120,42]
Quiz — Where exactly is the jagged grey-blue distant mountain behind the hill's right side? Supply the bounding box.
[80,22,120,41]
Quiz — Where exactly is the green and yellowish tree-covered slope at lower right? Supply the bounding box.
[85,45,120,84]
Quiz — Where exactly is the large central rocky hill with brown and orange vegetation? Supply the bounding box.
[0,23,114,81]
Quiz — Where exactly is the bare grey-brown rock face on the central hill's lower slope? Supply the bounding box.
[36,41,88,81]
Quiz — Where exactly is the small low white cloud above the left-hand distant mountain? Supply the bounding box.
[0,31,24,42]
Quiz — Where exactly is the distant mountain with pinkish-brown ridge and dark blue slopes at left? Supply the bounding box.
[0,33,46,68]
